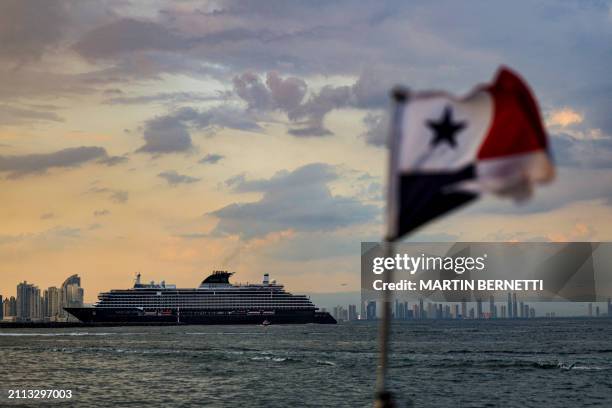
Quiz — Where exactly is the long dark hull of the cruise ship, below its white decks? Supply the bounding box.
[65,307,337,326]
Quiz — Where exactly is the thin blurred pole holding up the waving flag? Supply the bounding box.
[375,87,408,408]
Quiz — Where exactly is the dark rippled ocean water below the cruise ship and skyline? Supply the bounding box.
[0,319,612,407]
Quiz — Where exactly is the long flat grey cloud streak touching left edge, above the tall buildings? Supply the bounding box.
[0,146,107,179]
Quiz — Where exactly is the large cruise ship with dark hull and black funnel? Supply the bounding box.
[65,271,336,325]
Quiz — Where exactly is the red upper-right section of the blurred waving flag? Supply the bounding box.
[477,67,548,159]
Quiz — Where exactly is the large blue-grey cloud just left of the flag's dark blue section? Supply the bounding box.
[209,163,379,240]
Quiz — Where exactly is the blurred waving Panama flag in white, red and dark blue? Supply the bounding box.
[387,67,554,240]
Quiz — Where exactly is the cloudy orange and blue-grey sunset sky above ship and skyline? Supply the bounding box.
[0,0,612,302]
